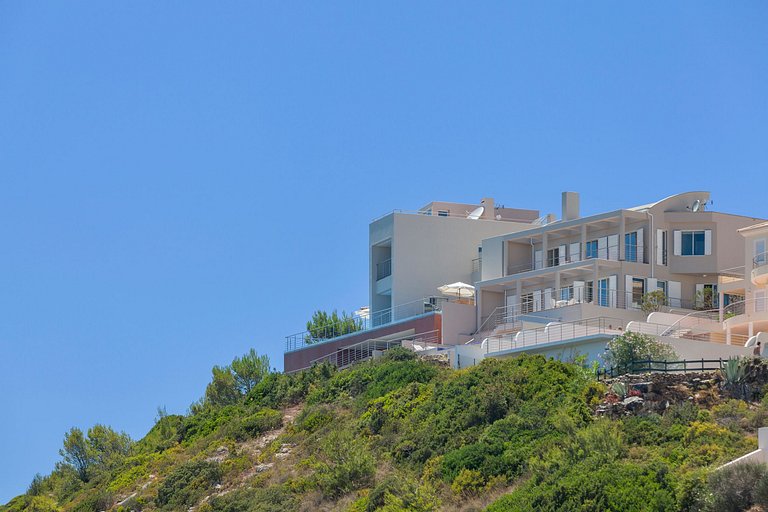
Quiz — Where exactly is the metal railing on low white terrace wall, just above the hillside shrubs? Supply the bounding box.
[482,317,623,354]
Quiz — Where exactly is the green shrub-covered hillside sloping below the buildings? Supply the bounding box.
[0,350,768,512]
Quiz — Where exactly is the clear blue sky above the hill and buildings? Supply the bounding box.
[0,0,768,502]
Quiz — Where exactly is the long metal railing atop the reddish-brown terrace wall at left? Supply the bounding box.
[285,297,456,352]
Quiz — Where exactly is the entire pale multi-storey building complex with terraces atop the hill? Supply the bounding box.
[285,192,768,372]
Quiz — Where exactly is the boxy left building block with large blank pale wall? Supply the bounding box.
[368,198,539,324]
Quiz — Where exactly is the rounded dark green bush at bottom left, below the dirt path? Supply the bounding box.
[156,461,221,510]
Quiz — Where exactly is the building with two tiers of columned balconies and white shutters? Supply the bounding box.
[476,192,758,325]
